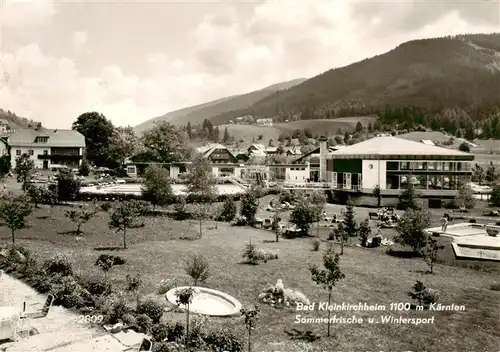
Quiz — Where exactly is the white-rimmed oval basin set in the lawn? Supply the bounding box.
[166,286,242,317]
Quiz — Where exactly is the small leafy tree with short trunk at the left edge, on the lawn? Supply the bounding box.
[0,194,33,245]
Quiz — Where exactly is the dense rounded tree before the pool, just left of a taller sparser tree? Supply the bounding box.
[142,165,174,209]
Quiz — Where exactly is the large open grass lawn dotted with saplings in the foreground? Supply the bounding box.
[0,206,500,352]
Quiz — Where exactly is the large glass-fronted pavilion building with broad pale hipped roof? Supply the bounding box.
[323,136,474,207]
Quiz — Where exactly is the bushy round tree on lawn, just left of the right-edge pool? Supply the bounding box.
[394,209,431,253]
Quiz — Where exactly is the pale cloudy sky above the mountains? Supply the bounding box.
[0,0,500,128]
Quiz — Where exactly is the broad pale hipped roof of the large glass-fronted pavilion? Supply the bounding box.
[331,136,474,160]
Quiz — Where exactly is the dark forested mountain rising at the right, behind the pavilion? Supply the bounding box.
[211,33,500,124]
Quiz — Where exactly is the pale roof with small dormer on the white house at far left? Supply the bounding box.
[8,128,85,148]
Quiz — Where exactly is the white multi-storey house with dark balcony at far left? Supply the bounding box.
[7,128,85,169]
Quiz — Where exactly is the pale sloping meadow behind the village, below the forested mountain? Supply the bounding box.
[219,116,376,145]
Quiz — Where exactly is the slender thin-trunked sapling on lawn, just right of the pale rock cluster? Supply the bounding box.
[309,243,345,337]
